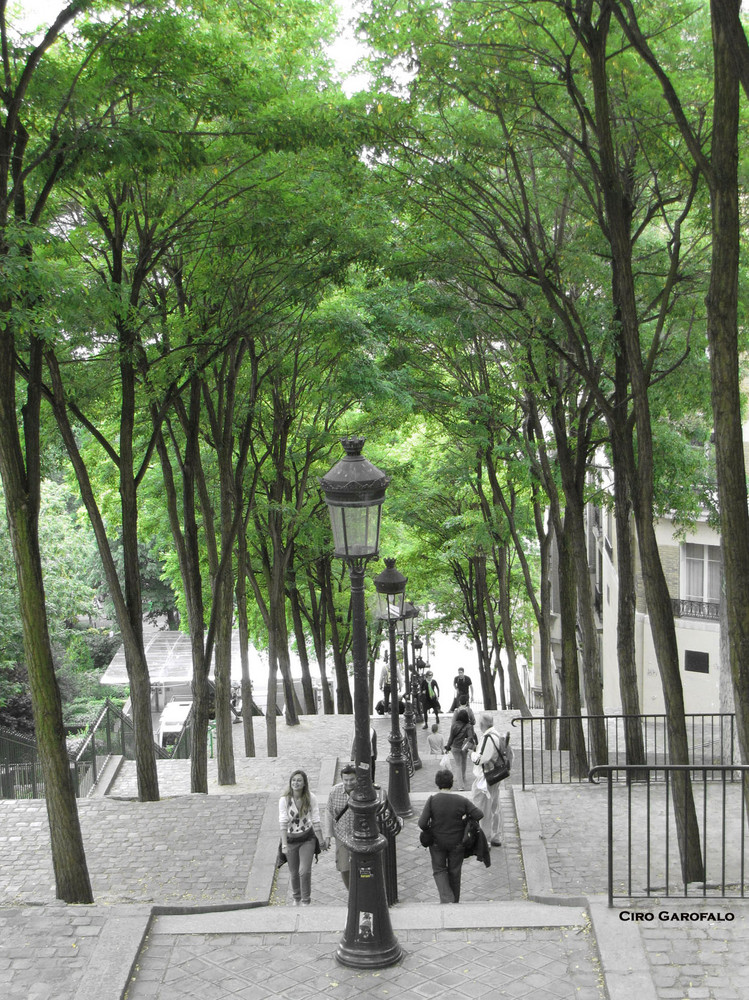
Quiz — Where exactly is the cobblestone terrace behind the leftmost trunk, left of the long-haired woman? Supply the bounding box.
[0,795,267,905]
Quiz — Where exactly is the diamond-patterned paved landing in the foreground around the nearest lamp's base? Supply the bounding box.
[122,928,605,1000]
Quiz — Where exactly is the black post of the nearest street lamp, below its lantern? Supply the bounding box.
[336,561,402,969]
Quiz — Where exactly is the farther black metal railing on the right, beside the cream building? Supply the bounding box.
[512,712,740,788]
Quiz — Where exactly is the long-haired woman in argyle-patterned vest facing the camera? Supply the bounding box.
[278,770,328,906]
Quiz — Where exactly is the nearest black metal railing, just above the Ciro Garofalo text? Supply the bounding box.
[590,764,749,906]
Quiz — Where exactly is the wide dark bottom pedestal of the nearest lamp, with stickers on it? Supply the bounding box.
[335,837,403,969]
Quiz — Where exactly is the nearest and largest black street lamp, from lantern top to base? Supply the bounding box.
[320,438,402,969]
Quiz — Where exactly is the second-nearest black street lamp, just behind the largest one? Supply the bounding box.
[374,559,413,816]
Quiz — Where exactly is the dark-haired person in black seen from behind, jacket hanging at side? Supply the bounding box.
[419,770,484,903]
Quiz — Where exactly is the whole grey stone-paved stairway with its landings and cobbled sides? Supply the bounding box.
[0,716,749,1000]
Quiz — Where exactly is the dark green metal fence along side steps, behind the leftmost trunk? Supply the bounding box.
[0,700,170,799]
